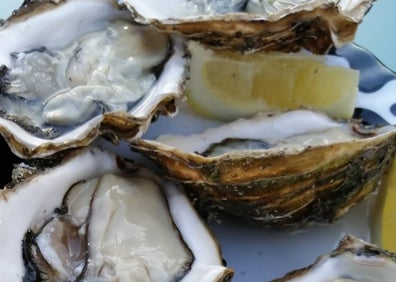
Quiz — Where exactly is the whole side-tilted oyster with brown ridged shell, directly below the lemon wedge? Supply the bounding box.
[131,110,396,228]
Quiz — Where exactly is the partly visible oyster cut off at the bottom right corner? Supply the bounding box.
[273,235,396,282]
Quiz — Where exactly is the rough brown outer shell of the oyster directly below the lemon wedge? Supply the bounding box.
[132,123,396,229]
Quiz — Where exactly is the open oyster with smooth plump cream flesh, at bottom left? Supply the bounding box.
[0,147,233,281]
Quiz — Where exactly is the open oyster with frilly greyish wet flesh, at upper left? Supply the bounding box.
[0,0,185,158]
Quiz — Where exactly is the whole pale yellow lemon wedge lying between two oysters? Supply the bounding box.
[186,42,359,120]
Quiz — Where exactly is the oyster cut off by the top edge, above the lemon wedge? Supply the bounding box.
[120,0,373,54]
